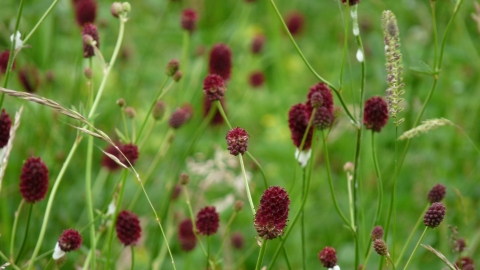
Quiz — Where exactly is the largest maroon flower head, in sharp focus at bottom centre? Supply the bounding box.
[254,186,290,240]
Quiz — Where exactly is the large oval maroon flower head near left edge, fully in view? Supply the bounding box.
[20,157,48,203]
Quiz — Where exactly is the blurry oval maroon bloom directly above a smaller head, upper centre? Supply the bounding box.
[209,43,232,81]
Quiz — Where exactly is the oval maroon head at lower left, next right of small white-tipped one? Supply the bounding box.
[115,210,142,246]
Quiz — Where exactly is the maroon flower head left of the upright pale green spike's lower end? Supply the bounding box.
[363,97,388,132]
